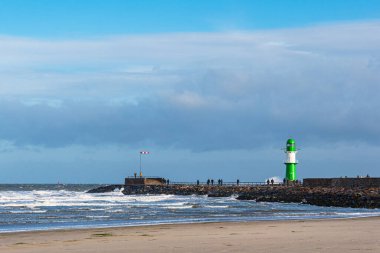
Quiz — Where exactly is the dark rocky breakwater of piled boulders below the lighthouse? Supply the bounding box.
[88,185,380,208]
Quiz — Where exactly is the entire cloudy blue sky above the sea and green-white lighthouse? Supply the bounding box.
[0,0,380,183]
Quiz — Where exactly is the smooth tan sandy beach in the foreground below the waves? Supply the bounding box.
[0,217,380,253]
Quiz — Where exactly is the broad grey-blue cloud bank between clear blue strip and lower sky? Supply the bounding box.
[0,22,380,151]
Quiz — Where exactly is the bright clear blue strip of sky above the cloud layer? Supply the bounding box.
[0,0,380,38]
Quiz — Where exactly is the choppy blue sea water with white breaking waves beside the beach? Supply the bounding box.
[0,185,380,233]
